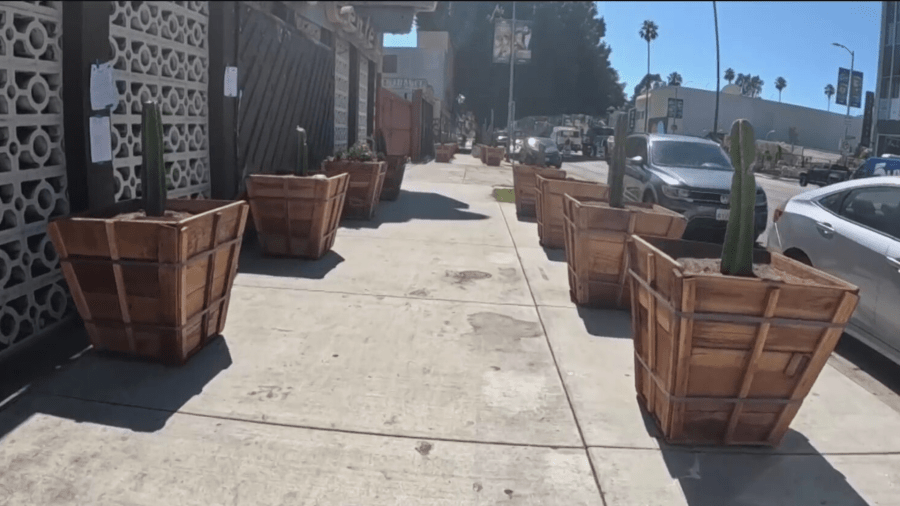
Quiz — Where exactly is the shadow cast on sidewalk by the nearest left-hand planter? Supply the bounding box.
[0,336,232,438]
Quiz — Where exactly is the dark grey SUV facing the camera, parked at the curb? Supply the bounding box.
[625,134,768,242]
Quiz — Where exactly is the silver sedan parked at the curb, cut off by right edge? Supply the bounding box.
[768,176,900,364]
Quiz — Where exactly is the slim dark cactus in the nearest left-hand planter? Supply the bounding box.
[141,102,167,216]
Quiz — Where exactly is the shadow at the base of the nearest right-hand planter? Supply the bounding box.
[636,399,874,506]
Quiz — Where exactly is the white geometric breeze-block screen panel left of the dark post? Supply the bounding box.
[0,2,74,353]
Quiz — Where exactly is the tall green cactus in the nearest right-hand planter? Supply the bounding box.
[721,119,756,276]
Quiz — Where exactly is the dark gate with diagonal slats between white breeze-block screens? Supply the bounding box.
[237,5,336,173]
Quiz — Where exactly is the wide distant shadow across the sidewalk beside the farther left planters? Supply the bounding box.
[341,190,488,229]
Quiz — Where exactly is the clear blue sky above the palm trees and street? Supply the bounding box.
[385,2,881,114]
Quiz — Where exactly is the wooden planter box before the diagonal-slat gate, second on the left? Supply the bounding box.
[247,174,350,259]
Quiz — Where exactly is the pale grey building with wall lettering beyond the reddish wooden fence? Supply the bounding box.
[382,31,455,138]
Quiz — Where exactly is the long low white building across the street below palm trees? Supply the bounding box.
[634,85,863,152]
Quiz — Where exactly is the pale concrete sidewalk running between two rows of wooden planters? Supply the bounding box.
[0,159,900,506]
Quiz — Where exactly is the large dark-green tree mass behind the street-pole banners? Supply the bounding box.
[416,2,627,123]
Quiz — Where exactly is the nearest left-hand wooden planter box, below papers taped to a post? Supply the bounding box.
[48,200,249,364]
